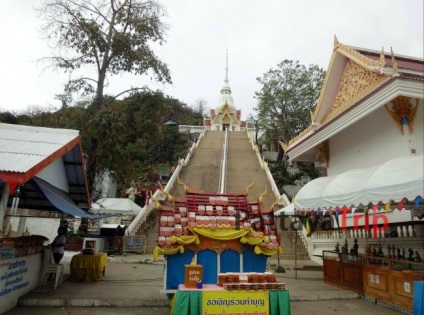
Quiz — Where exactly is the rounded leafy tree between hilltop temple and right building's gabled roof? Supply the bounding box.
[255,60,325,153]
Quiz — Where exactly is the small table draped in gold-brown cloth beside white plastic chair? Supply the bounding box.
[69,253,107,282]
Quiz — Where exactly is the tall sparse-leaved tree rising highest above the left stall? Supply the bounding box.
[37,0,171,191]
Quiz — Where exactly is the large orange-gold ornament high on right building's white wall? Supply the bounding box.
[384,96,419,134]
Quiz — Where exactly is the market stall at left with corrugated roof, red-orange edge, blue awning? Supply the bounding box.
[0,123,111,313]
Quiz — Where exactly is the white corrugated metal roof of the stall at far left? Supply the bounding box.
[0,123,79,173]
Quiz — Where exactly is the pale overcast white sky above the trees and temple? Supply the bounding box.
[0,0,424,119]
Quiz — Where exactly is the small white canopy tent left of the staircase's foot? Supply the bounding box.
[91,198,143,215]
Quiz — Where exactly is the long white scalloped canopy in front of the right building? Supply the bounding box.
[294,154,424,210]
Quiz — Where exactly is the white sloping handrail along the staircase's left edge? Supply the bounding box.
[126,130,205,235]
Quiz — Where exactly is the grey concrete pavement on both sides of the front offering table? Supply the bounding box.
[6,252,406,315]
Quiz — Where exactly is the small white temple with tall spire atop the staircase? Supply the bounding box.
[204,51,246,131]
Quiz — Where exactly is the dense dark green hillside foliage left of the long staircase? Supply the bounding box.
[0,90,194,197]
